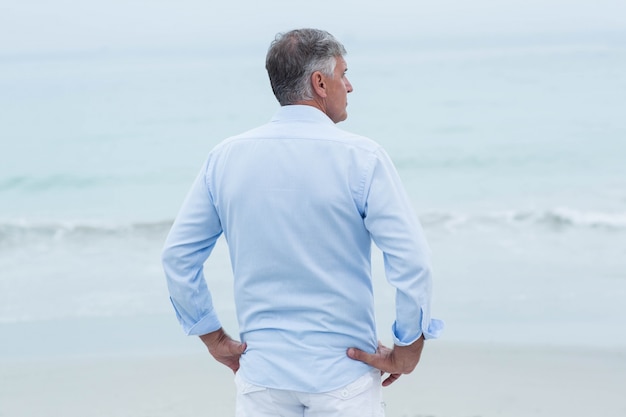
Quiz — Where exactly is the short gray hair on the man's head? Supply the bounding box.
[265,29,346,106]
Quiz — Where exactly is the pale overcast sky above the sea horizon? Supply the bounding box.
[0,0,626,54]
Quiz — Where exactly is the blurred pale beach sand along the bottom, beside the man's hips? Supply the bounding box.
[0,341,626,417]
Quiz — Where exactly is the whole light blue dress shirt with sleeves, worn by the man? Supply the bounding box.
[163,105,443,393]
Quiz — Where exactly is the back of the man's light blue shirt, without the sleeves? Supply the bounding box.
[206,106,378,392]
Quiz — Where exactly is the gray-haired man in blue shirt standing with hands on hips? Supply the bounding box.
[163,29,442,417]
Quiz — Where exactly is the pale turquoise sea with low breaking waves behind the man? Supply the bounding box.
[0,33,626,357]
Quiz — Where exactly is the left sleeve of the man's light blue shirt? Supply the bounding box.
[162,158,222,335]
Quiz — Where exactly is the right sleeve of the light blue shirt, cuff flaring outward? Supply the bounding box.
[364,149,443,346]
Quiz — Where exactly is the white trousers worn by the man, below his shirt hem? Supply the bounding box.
[235,369,385,417]
